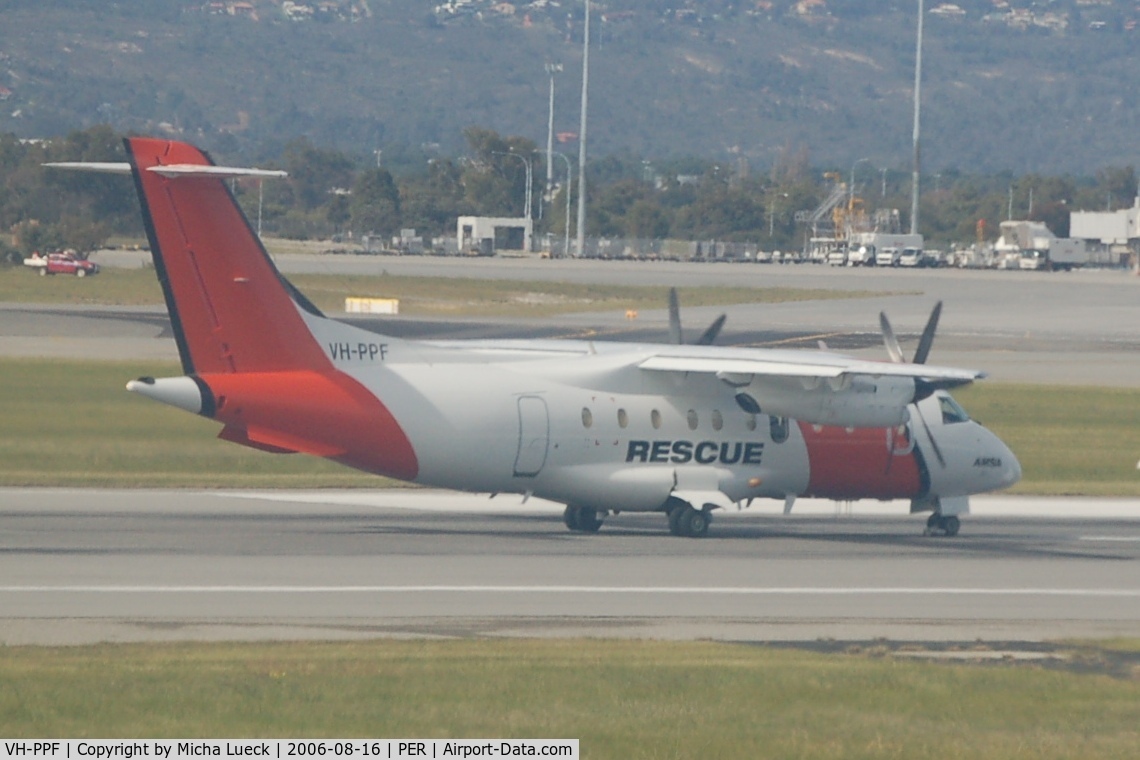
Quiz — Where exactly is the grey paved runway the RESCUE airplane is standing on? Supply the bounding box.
[0,489,1140,645]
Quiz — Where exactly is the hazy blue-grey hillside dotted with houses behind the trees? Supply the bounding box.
[0,0,1140,175]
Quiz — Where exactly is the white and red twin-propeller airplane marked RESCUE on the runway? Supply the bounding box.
[55,137,1021,538]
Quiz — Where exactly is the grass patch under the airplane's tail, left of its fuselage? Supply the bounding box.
[0,359,391,488]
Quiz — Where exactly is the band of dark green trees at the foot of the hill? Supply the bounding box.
[0,121,1137,260]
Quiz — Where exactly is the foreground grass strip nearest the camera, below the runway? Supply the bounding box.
[0,640,1140,760]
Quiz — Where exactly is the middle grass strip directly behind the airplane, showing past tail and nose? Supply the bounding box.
[0,359,1140,497]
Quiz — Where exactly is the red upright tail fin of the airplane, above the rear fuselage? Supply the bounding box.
[125,138,331,375]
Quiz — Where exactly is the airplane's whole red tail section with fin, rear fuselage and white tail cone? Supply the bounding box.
[119,138,418,480]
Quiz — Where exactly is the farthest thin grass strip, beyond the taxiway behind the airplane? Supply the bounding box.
[0,267,882,317]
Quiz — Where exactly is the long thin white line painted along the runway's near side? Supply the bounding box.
[0,585,1140,598]
